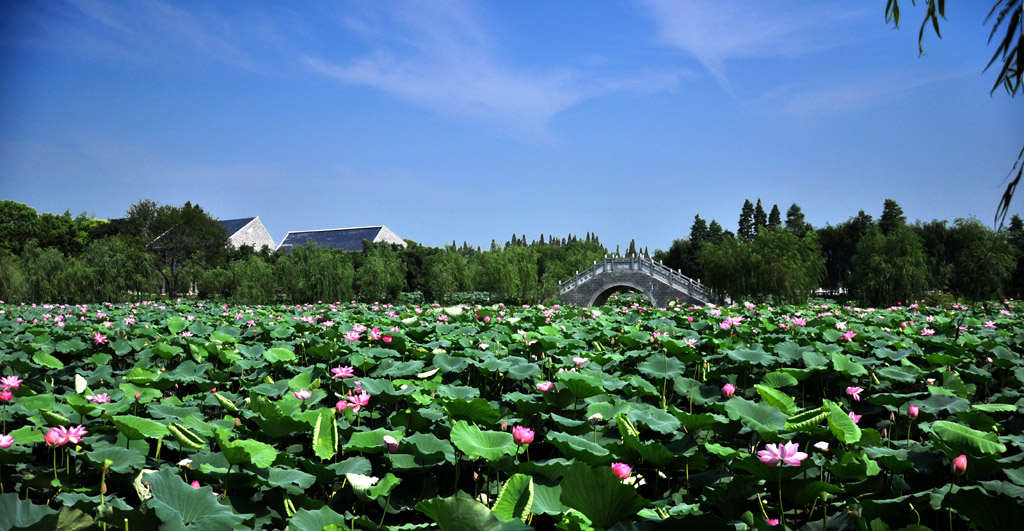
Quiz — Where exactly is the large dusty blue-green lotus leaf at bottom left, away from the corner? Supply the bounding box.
[143,467,252,529]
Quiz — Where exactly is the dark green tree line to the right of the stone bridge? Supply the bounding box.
[654,200,1024,306]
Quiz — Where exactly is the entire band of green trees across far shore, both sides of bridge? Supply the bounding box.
[0,200,1024,305]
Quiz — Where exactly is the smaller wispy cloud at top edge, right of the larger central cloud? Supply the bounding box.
[639,0,863,88]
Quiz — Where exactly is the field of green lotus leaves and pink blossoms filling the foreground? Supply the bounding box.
[0,299,1024,530]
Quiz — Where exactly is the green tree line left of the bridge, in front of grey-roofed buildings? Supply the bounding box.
[0,200,607,304]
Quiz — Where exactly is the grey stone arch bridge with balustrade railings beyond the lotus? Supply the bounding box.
[558,257,714,307]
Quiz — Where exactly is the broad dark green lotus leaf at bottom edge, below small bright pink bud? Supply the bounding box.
[559,462,649,529]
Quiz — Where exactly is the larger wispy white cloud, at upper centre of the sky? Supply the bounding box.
[303,2,680,140]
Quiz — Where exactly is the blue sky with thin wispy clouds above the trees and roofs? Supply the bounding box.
[0,0,1024,252]
